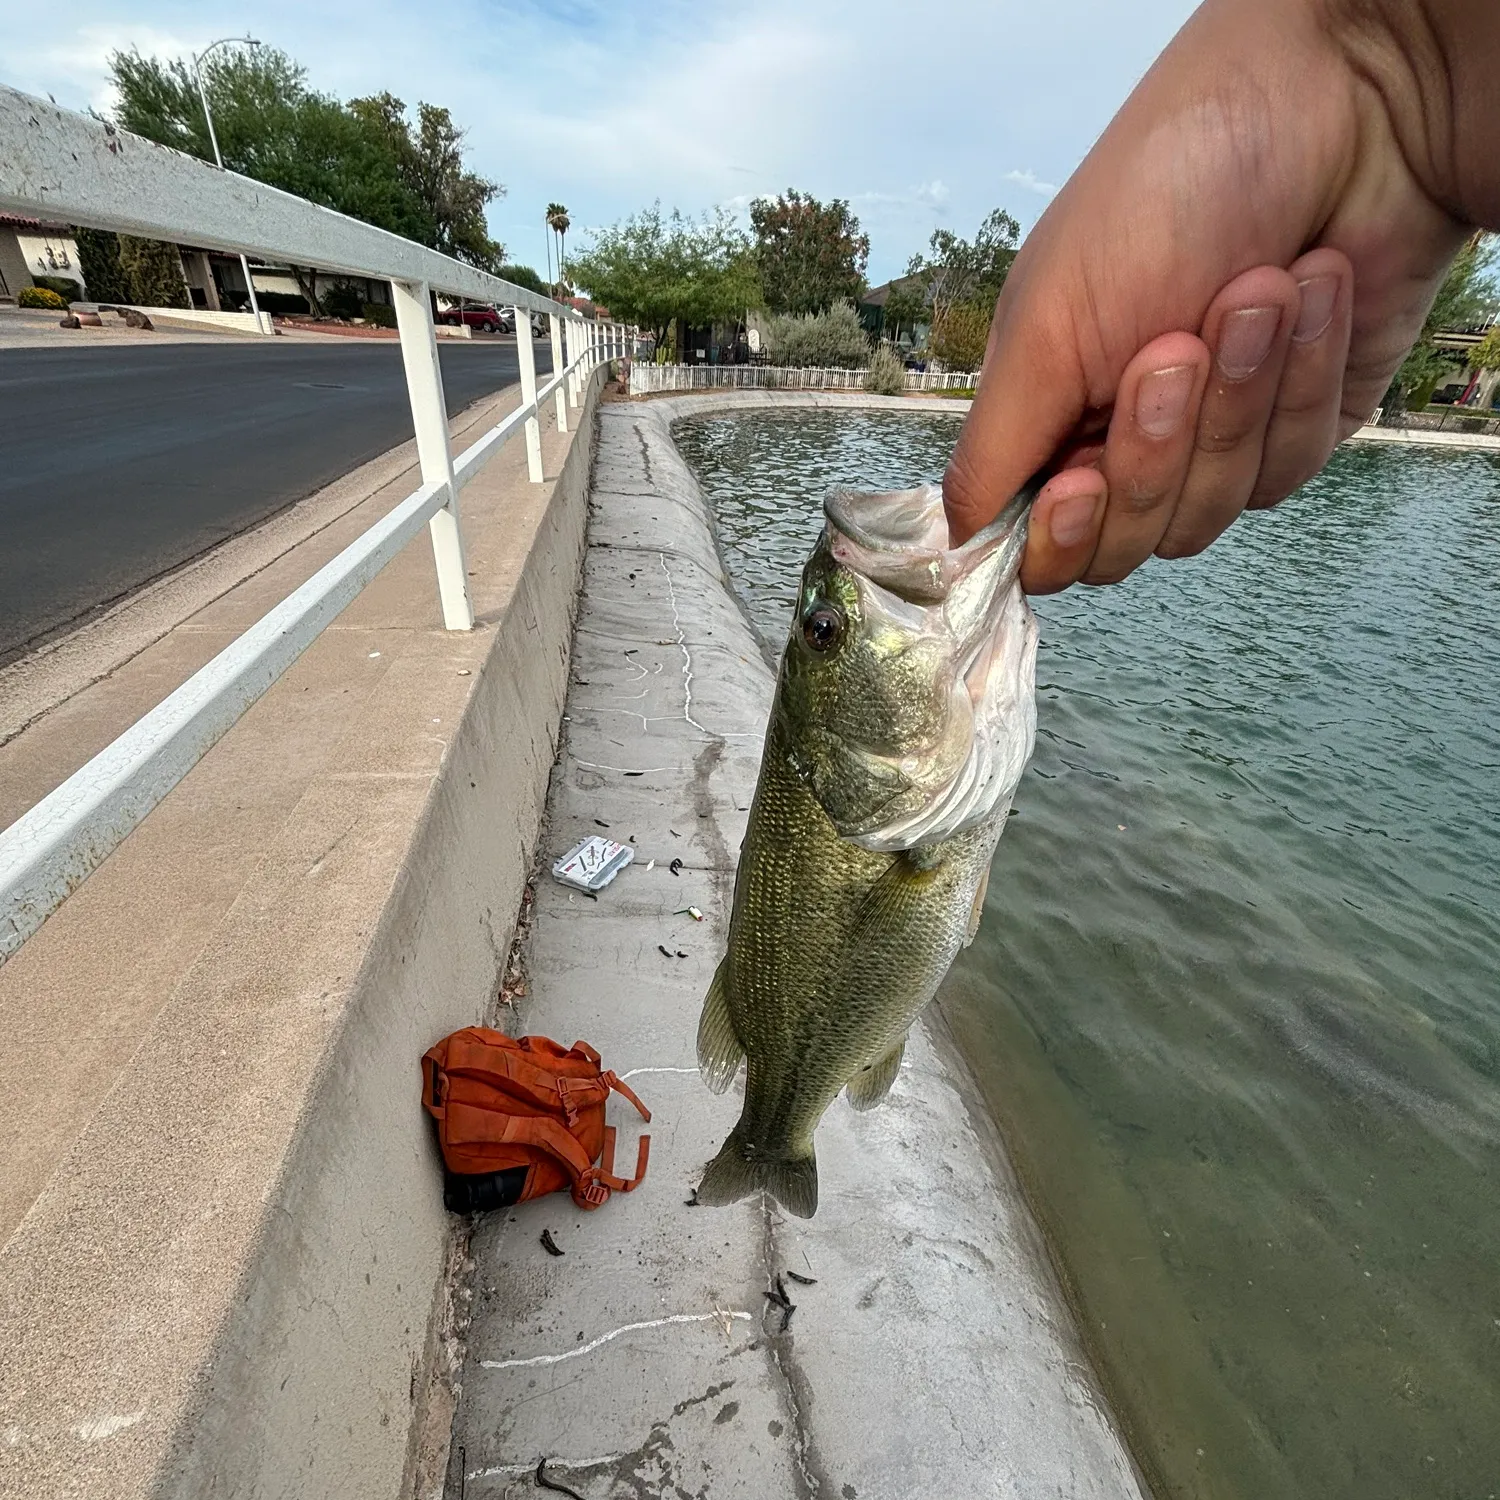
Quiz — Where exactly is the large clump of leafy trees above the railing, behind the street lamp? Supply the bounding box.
[110,47,504,311]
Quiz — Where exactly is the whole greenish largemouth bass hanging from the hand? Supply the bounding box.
[698,485,1037,1218]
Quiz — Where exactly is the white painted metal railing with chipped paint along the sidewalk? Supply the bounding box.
[0,87,635,963]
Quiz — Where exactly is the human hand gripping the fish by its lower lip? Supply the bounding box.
[944,0,1482,593]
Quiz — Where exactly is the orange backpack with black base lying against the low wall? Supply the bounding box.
[422,1026,651,1214]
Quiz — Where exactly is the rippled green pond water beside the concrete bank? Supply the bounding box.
[678,413,1500,1500]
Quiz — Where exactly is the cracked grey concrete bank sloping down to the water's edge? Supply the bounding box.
[444,393,1140,1500]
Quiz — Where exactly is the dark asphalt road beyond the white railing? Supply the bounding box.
[0,338,552,663]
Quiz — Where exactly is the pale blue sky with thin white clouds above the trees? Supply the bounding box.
[0,0,1193,284]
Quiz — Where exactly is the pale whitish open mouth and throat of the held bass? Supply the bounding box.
[824,480,1040,852]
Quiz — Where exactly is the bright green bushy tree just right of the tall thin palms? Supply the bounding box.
[572,204,762,348]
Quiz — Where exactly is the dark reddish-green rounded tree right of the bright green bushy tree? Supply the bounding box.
[750,188,870,314]
